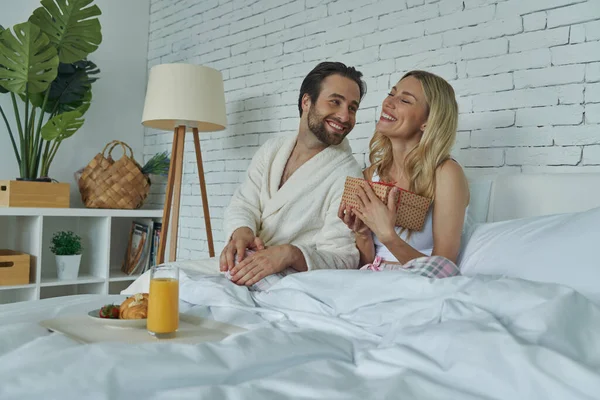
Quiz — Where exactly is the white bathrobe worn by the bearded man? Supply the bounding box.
[224,137,362,271]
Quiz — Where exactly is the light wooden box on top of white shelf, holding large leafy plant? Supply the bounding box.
[0,181,70,208]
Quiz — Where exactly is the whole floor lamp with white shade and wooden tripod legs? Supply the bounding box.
[142,64,227,264]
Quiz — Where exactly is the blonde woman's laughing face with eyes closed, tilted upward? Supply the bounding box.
[375,76,429,139]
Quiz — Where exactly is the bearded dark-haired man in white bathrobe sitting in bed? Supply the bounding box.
[219,62,366,286]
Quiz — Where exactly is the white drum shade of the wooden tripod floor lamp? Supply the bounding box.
[142,64,227,132]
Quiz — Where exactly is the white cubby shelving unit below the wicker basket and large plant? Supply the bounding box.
[0,208,168,304]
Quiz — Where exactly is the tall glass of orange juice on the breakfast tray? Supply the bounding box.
[146,264,179,339]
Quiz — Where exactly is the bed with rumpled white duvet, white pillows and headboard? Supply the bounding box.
[0,174,600,400]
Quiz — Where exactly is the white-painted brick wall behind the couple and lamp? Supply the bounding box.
[145,0,600,258]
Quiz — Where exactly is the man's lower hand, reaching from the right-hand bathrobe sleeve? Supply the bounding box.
[229,245,293,286]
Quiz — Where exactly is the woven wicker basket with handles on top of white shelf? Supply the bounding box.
[78,140,150,210]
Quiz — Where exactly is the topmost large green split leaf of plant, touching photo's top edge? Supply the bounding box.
[29,0,102,63]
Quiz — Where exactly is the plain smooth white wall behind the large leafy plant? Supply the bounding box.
[0,0,150,207]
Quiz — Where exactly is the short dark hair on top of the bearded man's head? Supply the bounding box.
[298,61,367,116]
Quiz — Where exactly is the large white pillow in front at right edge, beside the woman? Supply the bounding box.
[458,207,600,303]
